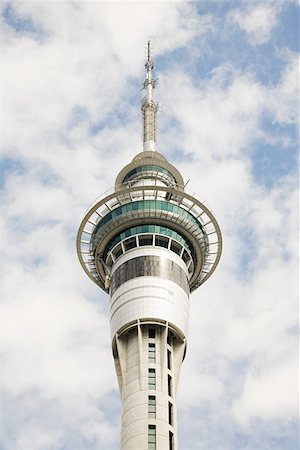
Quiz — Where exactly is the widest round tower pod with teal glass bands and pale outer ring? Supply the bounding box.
[77,185,222,291]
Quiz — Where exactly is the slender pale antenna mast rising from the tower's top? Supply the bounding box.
[141,41,158,151]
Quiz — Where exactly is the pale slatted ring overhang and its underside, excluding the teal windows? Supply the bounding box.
[77,185,222,292]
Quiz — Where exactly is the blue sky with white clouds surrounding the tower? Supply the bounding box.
[0,0,299,450]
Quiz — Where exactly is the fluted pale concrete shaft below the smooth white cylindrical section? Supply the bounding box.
[114,321,185,450]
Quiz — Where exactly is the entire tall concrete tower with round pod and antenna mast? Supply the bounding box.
[77,42,222,450]
